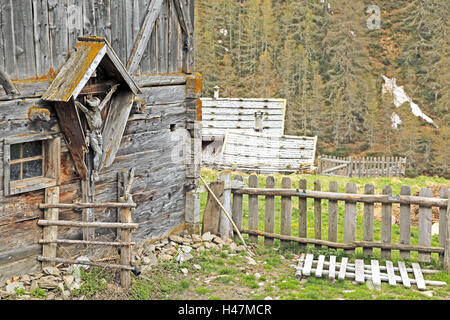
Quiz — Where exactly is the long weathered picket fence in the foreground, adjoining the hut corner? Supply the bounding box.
[205,173,450,265]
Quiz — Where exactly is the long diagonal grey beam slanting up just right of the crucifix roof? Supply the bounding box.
[127,0,163,75]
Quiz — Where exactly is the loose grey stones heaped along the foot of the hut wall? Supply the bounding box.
[0,232,245,300]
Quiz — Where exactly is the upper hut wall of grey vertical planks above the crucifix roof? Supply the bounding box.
[0,0,190,80]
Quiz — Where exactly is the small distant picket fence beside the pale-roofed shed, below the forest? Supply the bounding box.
[317,156,406,178]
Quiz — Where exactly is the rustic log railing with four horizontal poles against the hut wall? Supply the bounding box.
[37,172,139,288]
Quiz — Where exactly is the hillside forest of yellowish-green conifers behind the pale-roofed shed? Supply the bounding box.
[195,0,450,178]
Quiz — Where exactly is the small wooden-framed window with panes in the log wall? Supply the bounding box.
[3,137,61,195]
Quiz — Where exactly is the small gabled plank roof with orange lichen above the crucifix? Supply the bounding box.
[42,37,140,102]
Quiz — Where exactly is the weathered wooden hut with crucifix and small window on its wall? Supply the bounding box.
[0,0,201,282]
